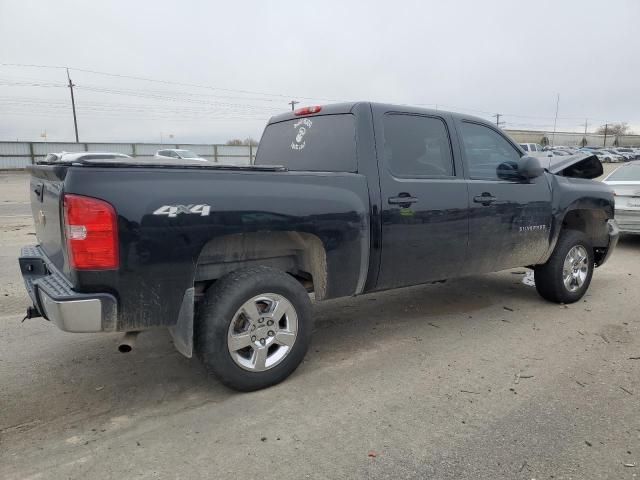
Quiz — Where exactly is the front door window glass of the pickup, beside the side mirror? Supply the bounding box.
[461,122,520,180]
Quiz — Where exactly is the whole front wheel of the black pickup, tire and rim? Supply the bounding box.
[534,230,594,303]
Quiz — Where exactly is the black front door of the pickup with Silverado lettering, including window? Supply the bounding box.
[457,120,552,273]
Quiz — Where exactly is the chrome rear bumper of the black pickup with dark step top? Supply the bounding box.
[19,245,118,333]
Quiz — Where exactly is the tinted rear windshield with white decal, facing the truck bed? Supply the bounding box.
[255,114,357,172]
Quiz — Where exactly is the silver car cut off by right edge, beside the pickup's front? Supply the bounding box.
[603,160,640,233]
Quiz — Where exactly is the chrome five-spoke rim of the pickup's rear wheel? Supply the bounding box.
[227,293,298,372]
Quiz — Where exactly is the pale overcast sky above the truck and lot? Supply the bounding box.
[0,0,640,143]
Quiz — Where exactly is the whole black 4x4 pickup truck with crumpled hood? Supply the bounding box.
[20,102,618,390]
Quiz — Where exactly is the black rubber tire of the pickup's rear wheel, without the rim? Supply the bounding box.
[194,267,313,391]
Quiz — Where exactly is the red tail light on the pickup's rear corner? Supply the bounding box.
[64,195,119,270]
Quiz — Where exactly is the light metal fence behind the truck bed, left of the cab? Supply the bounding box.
[0,142,258,170]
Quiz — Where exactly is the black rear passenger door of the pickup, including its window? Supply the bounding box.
[375,112,468,289]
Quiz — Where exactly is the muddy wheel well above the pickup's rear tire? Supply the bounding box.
[195,232,327,299]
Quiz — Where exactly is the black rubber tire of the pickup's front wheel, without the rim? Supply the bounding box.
[534,230,595,303]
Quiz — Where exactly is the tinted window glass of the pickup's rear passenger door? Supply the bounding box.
[384,113,454,177]
